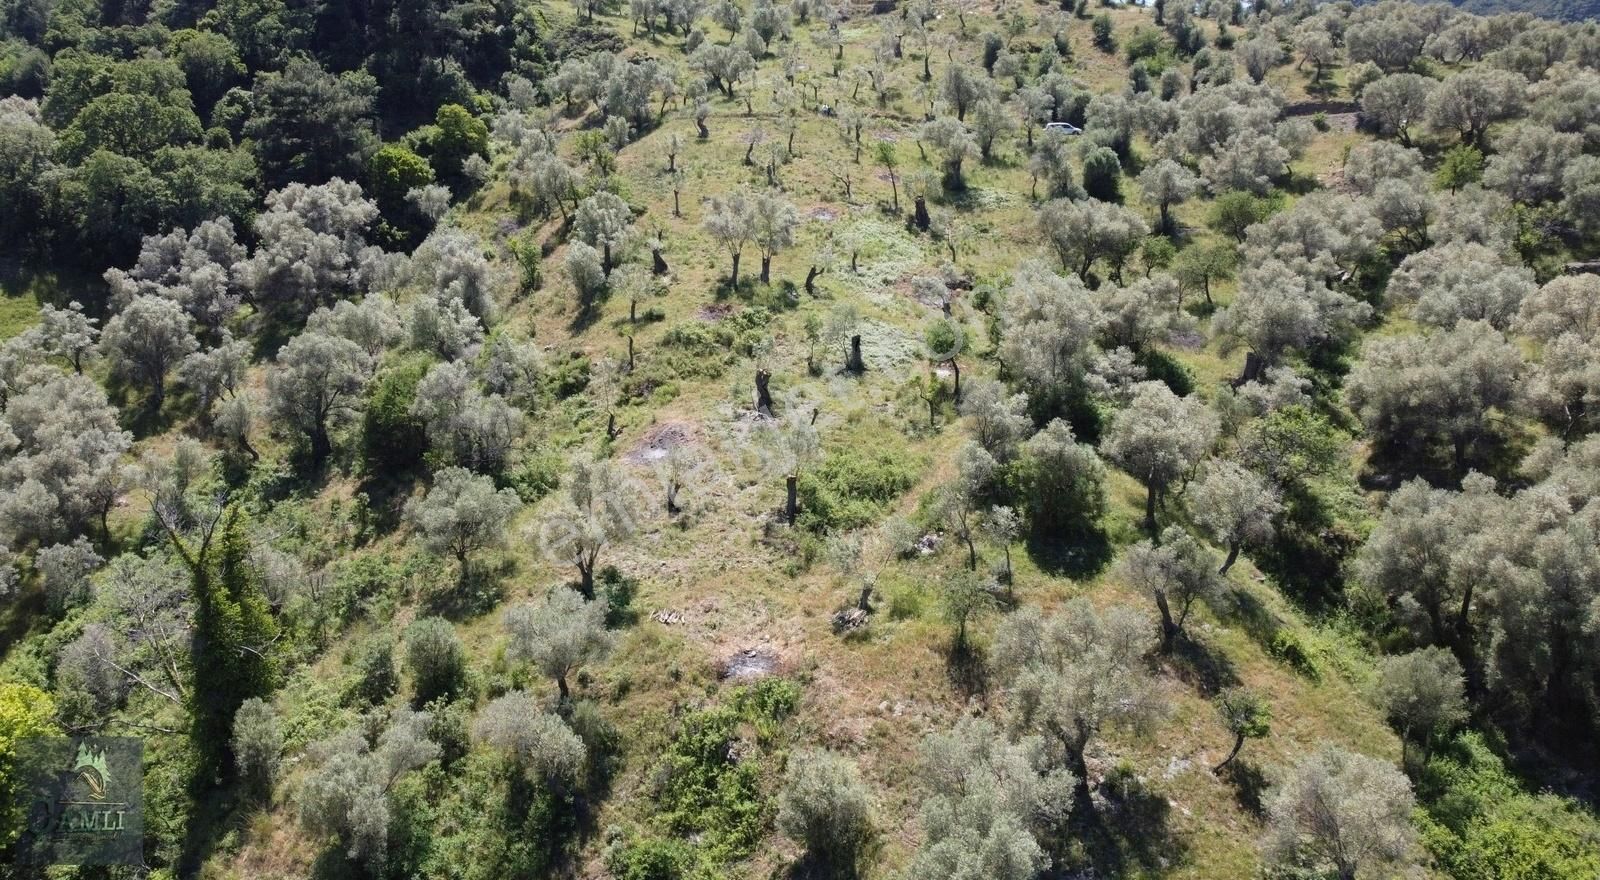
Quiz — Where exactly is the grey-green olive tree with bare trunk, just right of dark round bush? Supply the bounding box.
[1102,382,1221,534]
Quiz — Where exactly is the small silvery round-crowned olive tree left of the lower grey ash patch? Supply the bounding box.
[506,589,613,702]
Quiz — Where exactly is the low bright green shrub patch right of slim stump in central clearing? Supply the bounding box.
[798,445,918,533]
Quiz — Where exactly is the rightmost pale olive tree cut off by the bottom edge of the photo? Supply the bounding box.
[1267,746,1416,880]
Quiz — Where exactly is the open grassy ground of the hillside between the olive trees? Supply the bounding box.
[0,5,1600,880]
